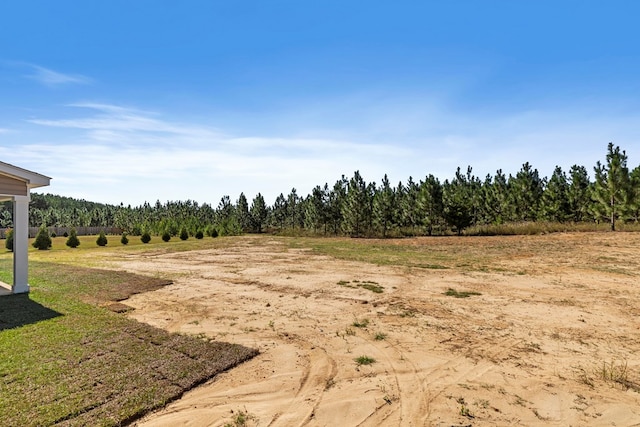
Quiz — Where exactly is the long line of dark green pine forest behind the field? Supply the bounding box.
[0,143,640,237]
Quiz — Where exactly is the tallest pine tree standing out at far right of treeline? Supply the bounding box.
[593,142,632,231]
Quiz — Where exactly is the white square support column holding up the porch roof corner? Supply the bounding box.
[11,195,30,294]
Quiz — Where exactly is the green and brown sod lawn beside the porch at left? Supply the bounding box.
[0,236,257,426]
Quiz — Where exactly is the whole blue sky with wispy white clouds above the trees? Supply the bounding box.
[0,0,640,206]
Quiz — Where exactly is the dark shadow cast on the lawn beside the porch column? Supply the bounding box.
[0,294,62,331]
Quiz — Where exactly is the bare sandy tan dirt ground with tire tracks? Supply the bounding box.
[118,233,640,427]
